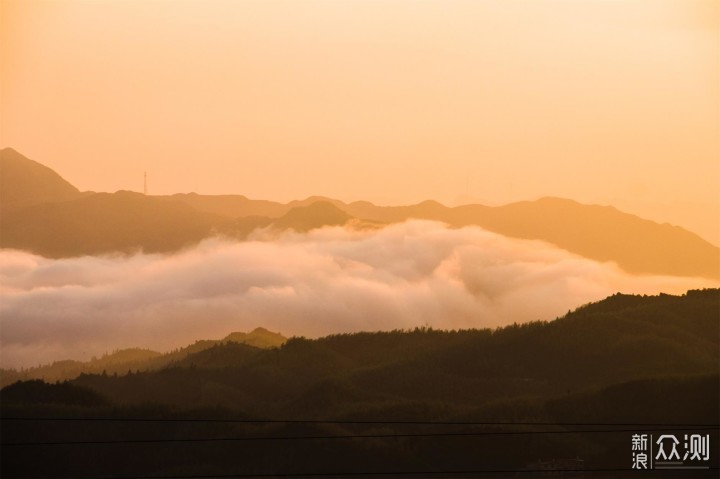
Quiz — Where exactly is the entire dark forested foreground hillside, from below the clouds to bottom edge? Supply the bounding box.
[0,290,720,477]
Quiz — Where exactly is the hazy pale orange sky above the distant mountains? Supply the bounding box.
[0,0,720,244]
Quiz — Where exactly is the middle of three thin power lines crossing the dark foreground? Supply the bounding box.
[0,427,715,447]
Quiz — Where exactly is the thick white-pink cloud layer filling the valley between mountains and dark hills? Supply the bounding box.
[0,221,717,367]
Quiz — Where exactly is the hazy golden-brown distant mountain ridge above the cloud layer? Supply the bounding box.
[0,148,720,279]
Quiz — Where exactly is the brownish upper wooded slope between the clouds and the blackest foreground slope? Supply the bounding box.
[66,290,720,415]
